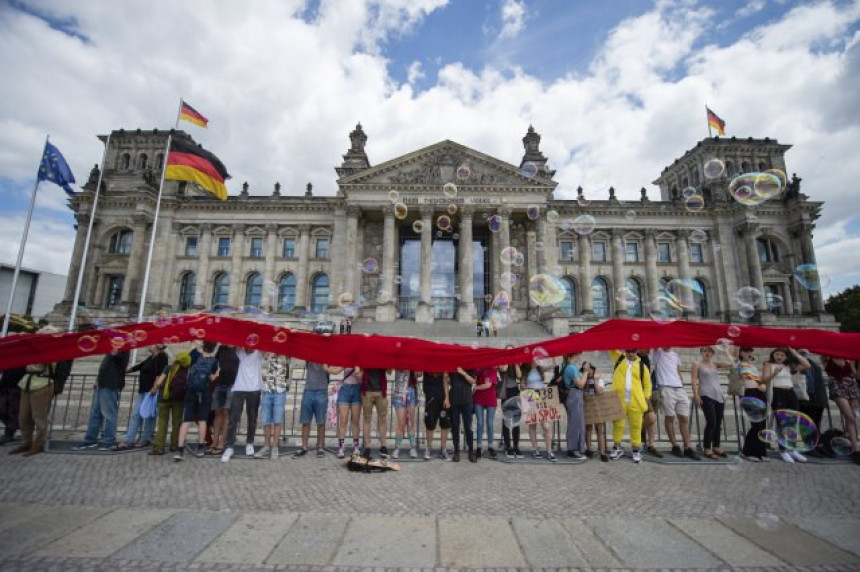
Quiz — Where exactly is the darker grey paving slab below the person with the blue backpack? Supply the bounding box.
[114,512,236,562]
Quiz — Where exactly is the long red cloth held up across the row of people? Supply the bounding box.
[0,314,860,371]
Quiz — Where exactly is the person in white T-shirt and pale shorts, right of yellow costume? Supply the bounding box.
[651,348,701,461]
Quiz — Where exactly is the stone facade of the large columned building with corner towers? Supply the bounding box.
[58,125,834,335]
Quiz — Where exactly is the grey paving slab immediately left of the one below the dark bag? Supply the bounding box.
[266,514,350,566]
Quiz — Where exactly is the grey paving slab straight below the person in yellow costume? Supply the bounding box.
[588,516,724,568]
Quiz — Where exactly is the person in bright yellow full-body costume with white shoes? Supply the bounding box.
[609,350,651,463]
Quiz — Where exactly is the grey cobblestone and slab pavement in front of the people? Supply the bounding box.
[0,448,860,571]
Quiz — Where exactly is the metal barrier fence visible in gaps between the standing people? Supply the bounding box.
[38,367,845,451]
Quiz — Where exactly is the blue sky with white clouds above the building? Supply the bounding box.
[0,0,860,300]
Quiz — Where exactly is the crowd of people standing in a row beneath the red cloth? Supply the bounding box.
[0,341,860,463]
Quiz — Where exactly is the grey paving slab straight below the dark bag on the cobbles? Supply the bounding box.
[331,515,436,568]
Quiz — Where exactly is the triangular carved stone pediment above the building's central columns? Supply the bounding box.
[338,140,558,191]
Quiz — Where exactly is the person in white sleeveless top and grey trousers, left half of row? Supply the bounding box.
[221,348,263,463]
